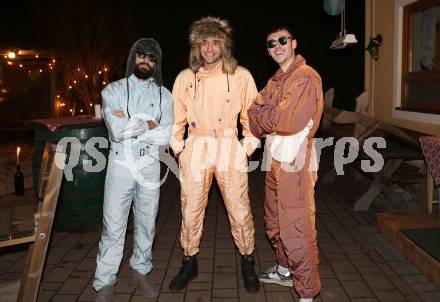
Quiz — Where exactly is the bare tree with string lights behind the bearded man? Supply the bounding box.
[34,0,135,114]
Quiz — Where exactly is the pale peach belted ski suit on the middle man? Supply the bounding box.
[171,60,259,256]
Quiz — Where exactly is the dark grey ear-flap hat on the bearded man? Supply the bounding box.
[125,38,163,86]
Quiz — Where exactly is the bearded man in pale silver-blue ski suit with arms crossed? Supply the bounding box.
[93,38,173,301]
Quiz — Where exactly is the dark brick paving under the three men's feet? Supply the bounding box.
[0,160,440,302]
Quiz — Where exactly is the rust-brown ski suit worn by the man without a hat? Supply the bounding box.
[249,55,323,298]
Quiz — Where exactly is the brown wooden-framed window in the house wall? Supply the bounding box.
[401,0,440,113]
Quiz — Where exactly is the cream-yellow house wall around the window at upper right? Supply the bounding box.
[365,0,440,136]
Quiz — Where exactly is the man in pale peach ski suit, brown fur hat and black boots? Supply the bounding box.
[170,17,259,292]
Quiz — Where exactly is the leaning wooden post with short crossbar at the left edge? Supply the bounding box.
[0,143,66,302]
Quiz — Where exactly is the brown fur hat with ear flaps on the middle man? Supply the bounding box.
[189,17,237,74]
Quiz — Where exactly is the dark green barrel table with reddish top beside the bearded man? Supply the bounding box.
[26,116,109,232]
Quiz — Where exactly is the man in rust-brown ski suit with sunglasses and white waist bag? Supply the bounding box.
[249,27,323,302]
